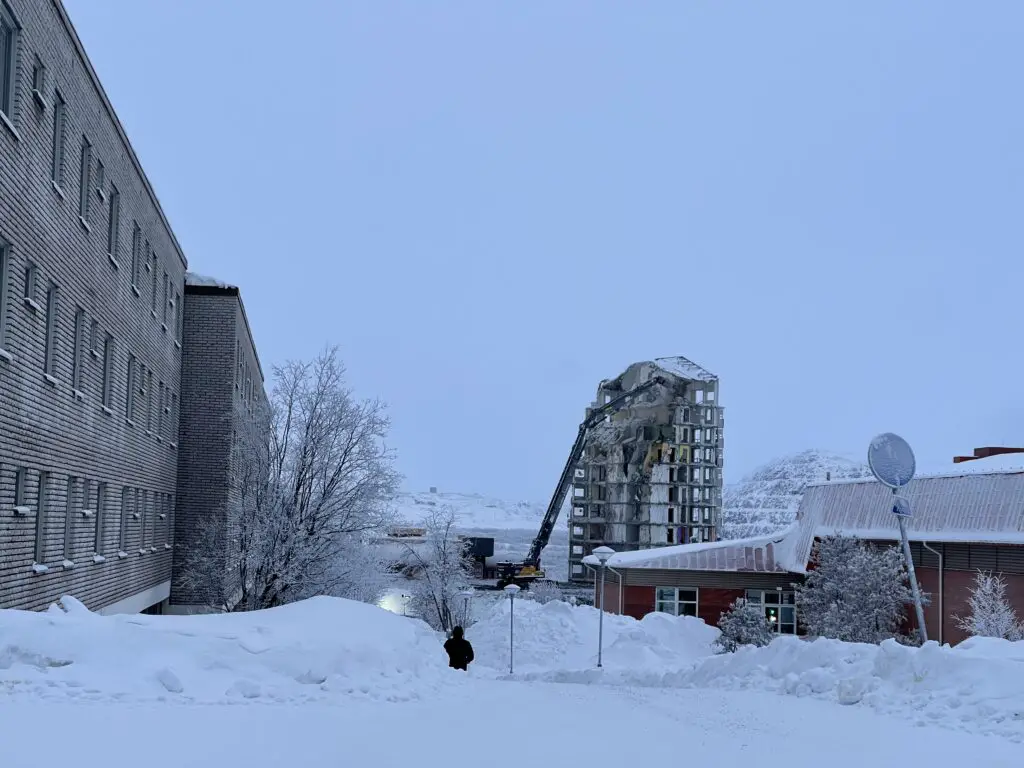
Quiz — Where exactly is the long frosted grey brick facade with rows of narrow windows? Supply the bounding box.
[0,0,262,612]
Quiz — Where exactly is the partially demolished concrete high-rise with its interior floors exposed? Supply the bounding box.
[568,357,725,582]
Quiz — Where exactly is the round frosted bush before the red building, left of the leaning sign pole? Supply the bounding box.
[797,537,927,643]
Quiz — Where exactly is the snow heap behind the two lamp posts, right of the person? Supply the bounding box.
[466,600,719,682]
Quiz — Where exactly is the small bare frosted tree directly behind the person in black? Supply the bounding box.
[406,507,473,632]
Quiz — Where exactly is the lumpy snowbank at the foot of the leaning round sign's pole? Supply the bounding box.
[679,637,1024,741]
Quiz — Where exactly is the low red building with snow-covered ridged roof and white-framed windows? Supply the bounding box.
[584,470,1024,643]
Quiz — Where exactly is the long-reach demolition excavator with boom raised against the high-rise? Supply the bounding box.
[498,376,672,589]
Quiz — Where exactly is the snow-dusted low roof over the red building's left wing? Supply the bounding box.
[583,529,806,573]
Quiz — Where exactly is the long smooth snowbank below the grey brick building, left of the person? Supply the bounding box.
[0,597,451,702]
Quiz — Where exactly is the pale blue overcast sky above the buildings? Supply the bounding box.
[65,0,1024,501]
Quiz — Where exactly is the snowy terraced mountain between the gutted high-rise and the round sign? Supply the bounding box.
[721,451,871,539]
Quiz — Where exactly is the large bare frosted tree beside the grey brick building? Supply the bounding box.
[177,348,399,610]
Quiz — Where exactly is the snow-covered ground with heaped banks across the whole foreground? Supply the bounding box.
[0,598,1024,768]
